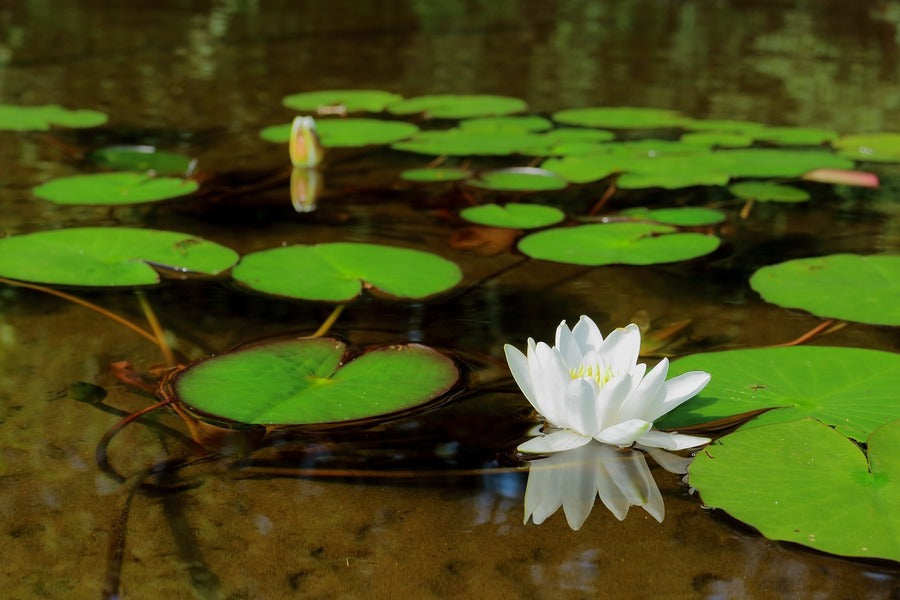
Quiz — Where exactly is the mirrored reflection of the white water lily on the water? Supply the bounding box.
[525,441,691,530]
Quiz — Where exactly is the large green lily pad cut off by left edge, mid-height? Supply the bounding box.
[0,227,238,287]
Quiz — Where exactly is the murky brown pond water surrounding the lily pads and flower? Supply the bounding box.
[0,0,900,599]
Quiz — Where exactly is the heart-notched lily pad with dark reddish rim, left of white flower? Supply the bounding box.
[174,338,459,425]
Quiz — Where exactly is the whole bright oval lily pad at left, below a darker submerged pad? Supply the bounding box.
[33,172,199,205]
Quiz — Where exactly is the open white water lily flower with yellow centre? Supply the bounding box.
[504,316,710,454]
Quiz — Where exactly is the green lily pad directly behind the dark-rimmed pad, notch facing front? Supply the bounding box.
[232,242,462,302]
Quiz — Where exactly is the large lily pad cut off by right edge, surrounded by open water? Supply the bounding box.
[750,254,900,325]
